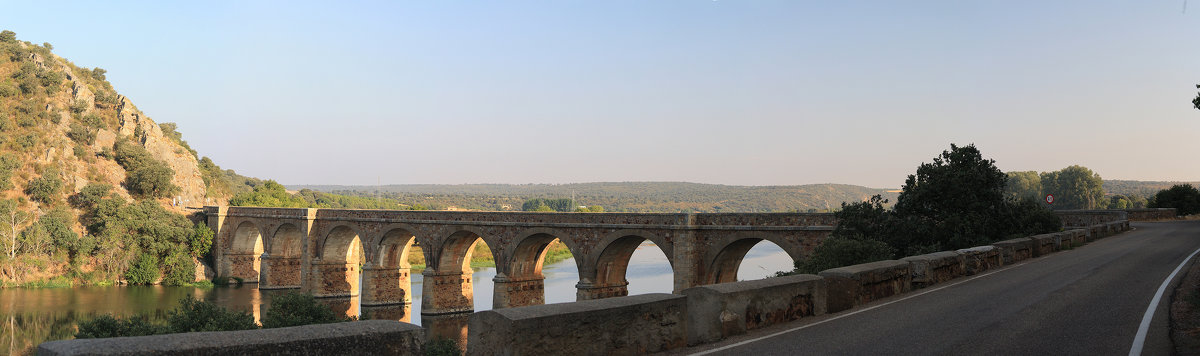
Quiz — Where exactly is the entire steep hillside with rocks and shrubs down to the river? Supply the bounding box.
[0,31,257,285]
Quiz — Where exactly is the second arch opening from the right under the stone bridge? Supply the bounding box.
[577,235,674,300]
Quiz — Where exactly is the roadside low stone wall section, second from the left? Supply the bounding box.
[467,294,688,355]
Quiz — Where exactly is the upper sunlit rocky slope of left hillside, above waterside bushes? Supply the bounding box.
[0,32,228,215]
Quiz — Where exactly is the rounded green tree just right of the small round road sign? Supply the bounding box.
[1042,165,1108,209]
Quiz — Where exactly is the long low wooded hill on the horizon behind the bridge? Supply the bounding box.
[287,182,896,212]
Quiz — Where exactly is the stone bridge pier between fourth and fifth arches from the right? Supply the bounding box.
[421,268,475,315]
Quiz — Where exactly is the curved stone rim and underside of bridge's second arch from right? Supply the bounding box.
[577,230,674,300]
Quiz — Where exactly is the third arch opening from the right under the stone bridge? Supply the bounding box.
[493,233,580,308]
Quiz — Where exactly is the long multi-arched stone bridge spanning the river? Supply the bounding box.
[204,206,835,315]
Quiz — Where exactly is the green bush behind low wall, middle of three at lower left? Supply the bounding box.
[167,295,258,332]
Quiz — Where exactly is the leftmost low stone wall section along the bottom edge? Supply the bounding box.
[37,320,425,355]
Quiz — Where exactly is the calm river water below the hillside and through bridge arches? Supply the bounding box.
[0,242,792,354]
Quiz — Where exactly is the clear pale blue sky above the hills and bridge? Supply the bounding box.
[0,0,1200,187]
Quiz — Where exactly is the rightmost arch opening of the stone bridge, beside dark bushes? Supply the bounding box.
[706,237,794,284]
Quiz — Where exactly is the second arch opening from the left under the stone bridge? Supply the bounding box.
[260,223,304,289]
